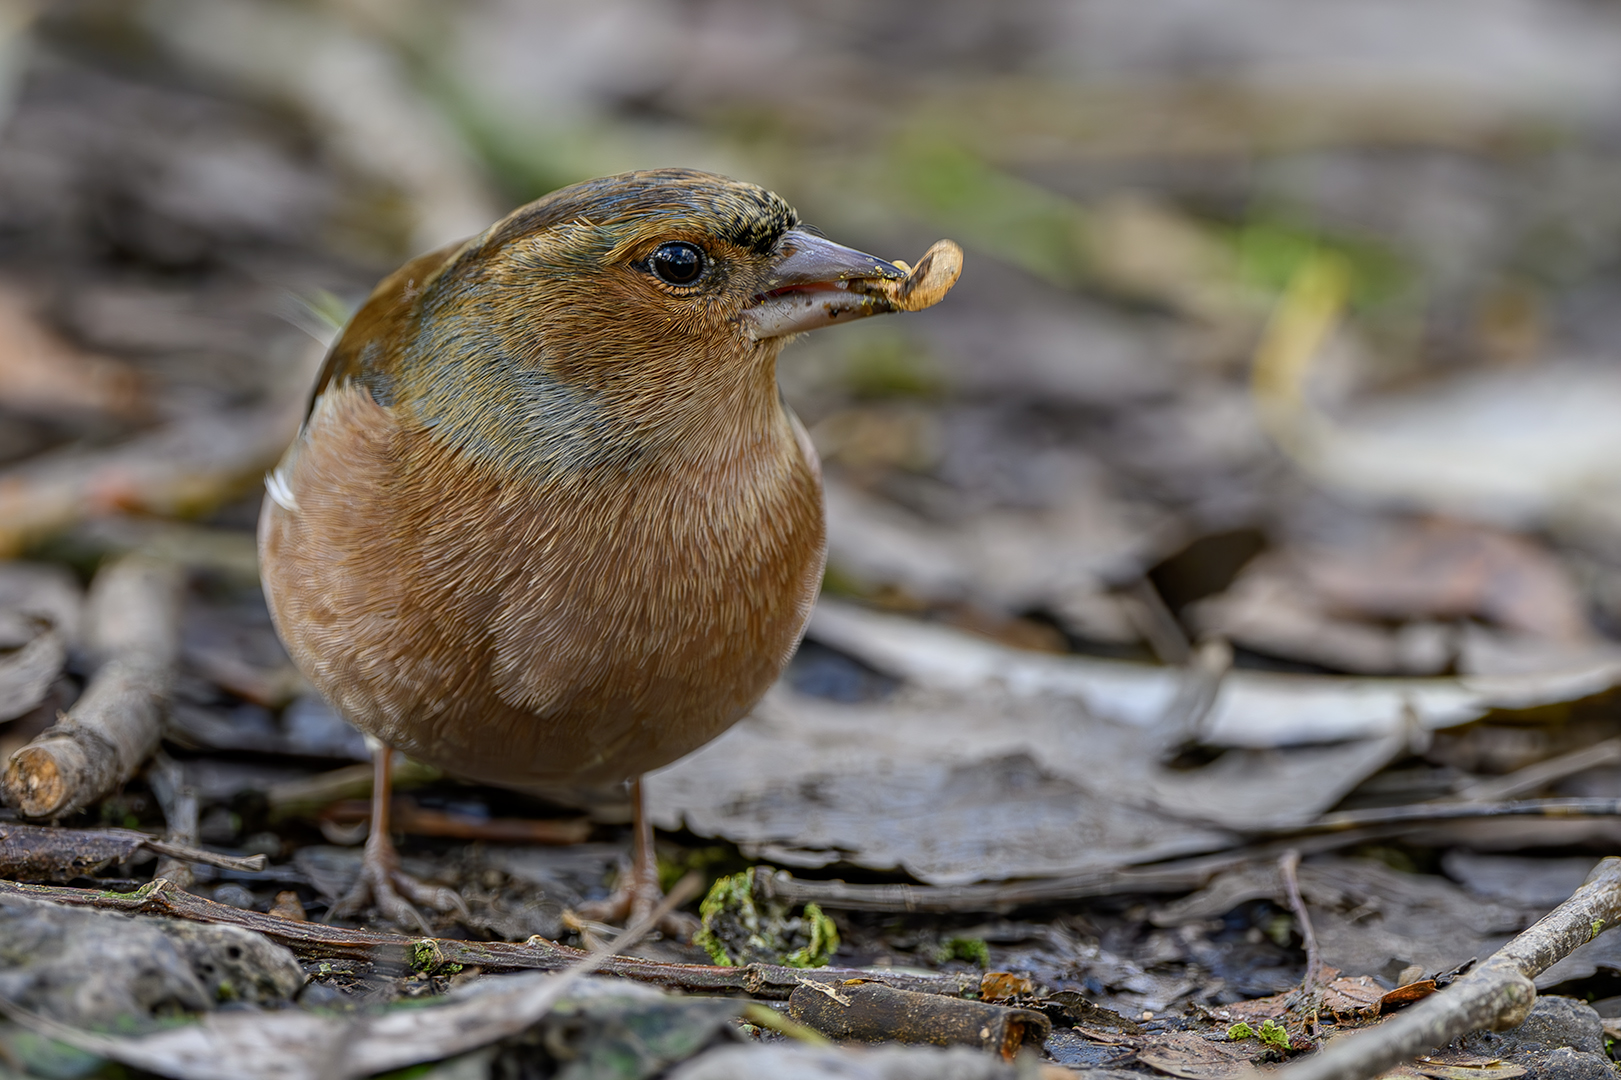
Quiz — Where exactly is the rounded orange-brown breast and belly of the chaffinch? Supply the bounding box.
[261,376,825,783]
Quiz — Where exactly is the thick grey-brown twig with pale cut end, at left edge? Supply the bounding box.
[0,555,180,819]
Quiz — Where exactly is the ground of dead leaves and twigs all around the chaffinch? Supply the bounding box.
[0,0,1621,1078]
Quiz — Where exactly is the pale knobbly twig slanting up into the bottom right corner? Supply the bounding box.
[1268,858,1621,1080]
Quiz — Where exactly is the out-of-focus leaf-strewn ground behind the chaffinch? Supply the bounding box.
[9,0,1621,675]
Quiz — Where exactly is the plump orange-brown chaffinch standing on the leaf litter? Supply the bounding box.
[259,170,955,918]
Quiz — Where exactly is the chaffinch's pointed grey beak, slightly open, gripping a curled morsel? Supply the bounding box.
[742,229,906,341]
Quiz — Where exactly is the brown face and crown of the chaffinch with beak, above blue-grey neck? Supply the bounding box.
[446,169,906,372]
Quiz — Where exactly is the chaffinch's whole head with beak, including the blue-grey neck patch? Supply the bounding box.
[337,169,940,476]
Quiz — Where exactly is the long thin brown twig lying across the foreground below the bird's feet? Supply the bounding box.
[0,879,979,1001]
